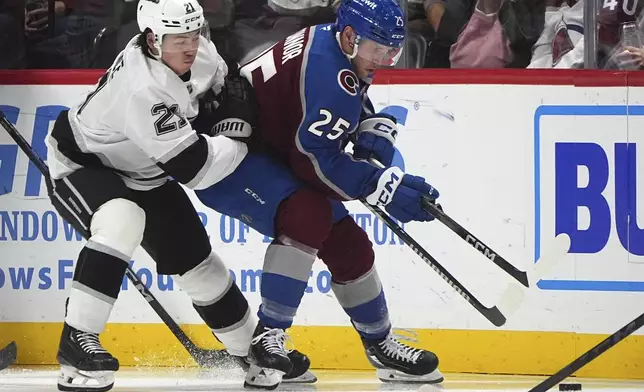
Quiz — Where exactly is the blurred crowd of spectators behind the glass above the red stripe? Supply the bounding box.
[0,0,644,69]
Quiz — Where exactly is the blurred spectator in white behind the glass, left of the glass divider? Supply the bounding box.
[528,0,584,68]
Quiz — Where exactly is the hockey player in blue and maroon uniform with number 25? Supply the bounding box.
[197,0,443,382]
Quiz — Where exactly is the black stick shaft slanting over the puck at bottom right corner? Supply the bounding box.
[529,313,644,392]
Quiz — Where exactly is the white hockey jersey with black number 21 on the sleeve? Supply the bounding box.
[46,37,248,190]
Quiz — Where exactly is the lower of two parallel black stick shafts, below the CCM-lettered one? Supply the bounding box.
[361,200,506,327]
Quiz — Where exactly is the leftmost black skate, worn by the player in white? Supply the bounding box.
[56,323,119,392]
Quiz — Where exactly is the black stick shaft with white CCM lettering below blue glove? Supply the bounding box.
[422,196,530,287]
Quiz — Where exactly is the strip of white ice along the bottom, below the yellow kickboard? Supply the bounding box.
[0,367,644,392]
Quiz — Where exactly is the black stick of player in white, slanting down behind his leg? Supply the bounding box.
[0,110,229,367]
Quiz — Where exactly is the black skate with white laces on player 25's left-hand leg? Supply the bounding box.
[244,322,293,389]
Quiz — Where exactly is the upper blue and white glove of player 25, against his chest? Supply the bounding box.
[353,113,398,166]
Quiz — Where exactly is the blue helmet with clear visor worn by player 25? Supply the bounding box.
[336,0,405,66]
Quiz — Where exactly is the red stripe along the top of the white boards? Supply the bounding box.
[0,69,644,87]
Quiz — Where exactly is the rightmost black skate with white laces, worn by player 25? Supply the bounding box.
[362,333,443,384]
